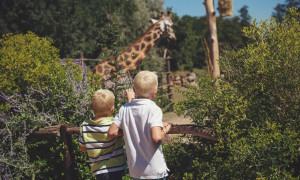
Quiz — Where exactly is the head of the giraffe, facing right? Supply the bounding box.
[151,11,176,40]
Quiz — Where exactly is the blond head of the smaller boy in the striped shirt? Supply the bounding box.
[91,89,115,116]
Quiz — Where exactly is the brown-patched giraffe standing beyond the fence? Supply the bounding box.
[93,12,176,79]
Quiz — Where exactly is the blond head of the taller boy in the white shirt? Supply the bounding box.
[134,71,158,98]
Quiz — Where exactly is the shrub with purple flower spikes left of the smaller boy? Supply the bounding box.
[0,63,101,179]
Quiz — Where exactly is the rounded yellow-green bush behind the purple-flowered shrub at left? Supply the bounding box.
[0,32,63,95]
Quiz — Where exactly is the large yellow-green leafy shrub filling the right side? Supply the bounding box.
[171,9,300,179]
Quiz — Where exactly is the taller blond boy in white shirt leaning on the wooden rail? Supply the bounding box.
[108,71,171,179]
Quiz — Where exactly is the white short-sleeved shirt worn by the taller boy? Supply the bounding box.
[114,99,168,179]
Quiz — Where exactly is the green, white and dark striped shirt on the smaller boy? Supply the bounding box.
[79,117,127,175]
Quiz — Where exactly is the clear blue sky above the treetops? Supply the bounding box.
[163,0,285,21]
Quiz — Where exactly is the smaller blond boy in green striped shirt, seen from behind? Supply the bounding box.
[79,89,127,180]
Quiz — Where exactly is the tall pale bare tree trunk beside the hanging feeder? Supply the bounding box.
[203,0,220,79]
